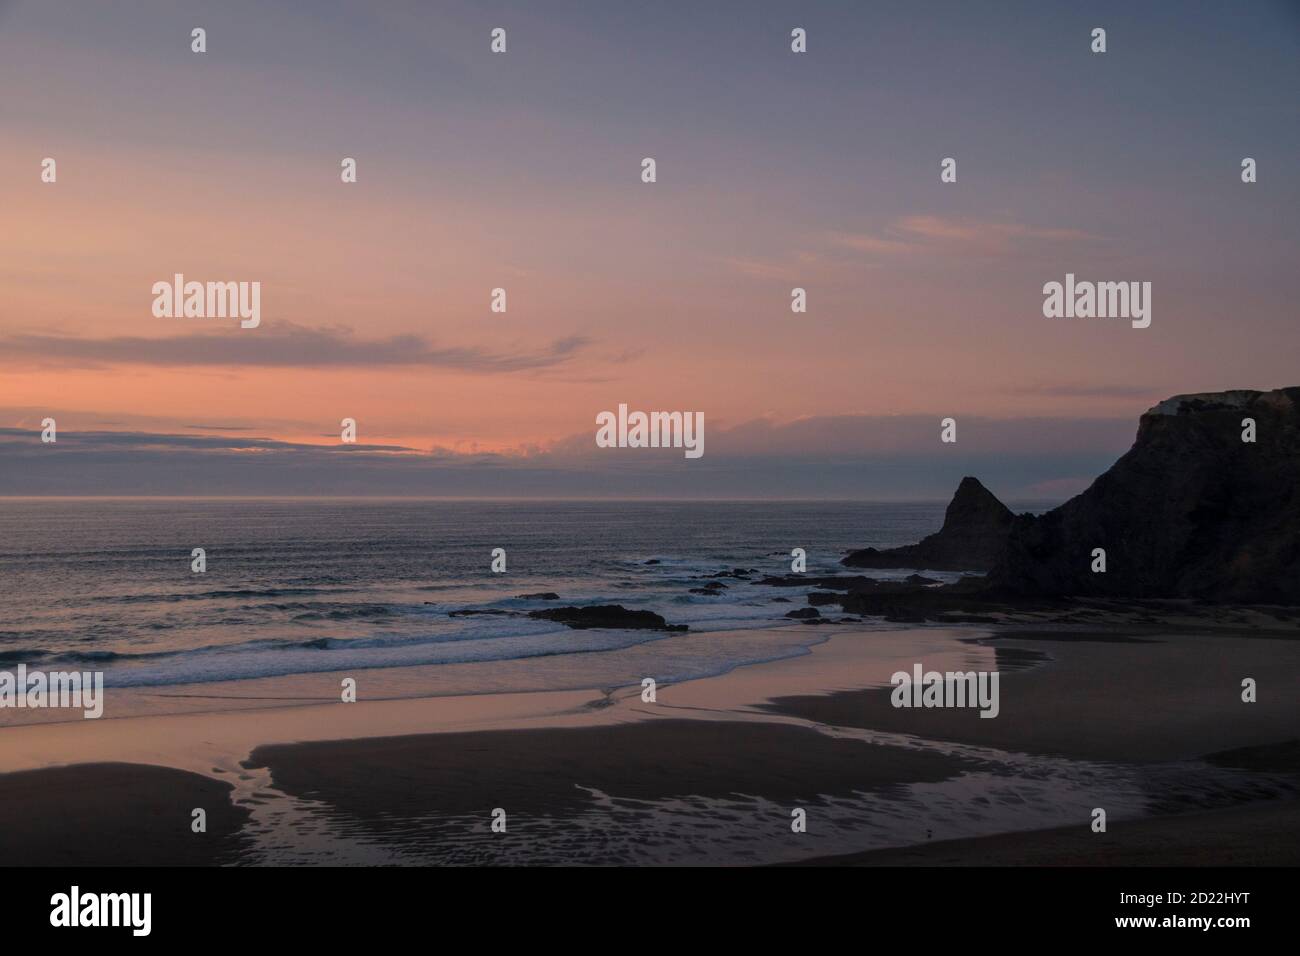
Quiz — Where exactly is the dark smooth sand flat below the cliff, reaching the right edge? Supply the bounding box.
[766,633,1300,761]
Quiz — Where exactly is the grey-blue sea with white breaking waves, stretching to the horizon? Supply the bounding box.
[0,498,977,689]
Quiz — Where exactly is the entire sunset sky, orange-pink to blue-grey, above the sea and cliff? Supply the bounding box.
[0,0,1300,498]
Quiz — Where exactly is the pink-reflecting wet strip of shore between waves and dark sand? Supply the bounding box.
[0,626,967,774]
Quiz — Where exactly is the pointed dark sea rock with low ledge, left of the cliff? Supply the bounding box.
[840,477,1015,571]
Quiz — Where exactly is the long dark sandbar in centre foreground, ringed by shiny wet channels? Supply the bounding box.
[247,719,974,818]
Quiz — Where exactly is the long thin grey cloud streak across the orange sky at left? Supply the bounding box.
[0,323,590,372]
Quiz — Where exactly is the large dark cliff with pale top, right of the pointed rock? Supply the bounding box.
[988,388,1300,605]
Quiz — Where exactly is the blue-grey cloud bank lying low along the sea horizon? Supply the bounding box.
[0,415,1132,501]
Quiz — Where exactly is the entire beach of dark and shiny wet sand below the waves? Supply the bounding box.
[0,627,1300,865]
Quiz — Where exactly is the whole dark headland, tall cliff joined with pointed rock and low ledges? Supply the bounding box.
[822,388,1300,620]
